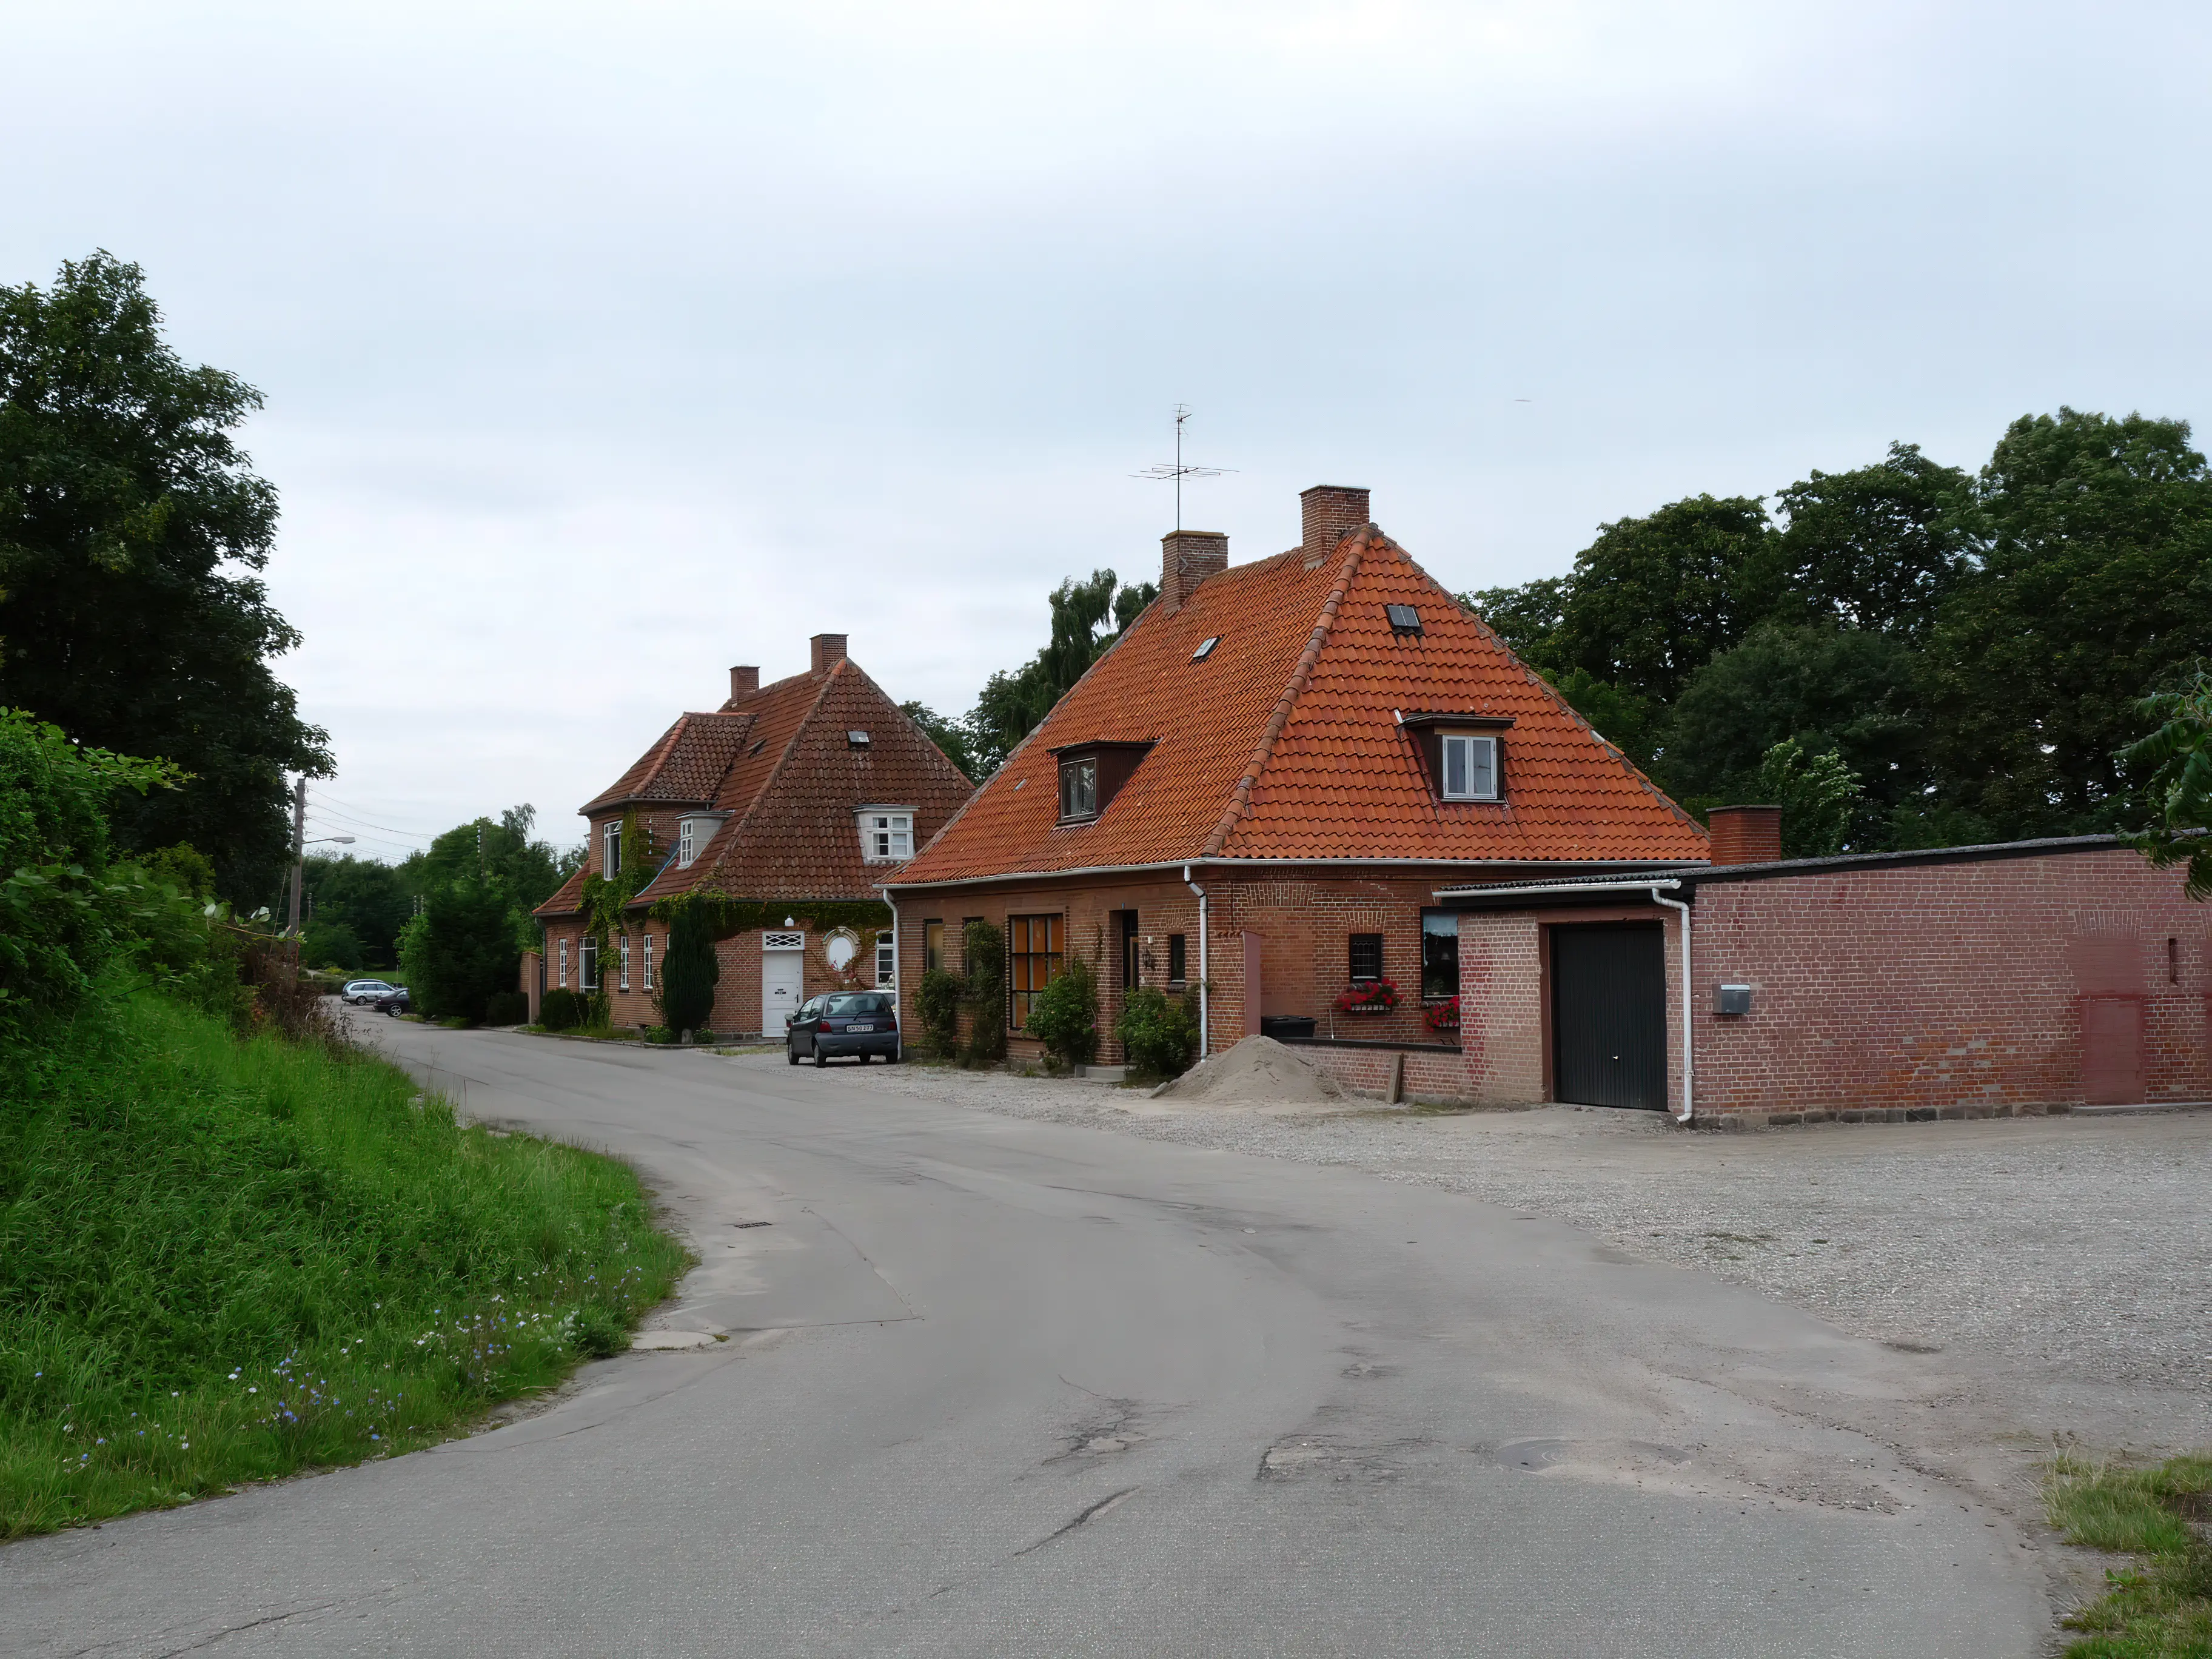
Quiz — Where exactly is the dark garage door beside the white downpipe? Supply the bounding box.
[1550,922,1666,1110]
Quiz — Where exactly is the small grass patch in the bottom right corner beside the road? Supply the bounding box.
[2044,1455,2212,1659]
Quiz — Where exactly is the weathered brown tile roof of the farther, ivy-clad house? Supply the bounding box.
[537,659,971,916]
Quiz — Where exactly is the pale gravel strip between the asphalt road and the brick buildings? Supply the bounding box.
[723,1051,2212,1453]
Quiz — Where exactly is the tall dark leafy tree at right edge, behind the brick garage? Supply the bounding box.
[1926,409,2212,839]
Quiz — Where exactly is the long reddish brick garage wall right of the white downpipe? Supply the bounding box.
[1694,850,2212,1119]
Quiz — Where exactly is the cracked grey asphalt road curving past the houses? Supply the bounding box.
[0,1035,2051,1659]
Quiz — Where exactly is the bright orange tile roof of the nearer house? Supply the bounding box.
[898,526,1706,887]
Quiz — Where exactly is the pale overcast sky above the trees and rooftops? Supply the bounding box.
[0,0,2212,871]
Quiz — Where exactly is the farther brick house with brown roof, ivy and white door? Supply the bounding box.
[537,632,971,1037]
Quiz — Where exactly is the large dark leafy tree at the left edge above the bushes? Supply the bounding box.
[0,252,332,900]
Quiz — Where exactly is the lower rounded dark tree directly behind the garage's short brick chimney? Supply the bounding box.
[1657,622,1926,847]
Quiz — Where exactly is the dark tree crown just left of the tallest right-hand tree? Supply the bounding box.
[1748,443,1973,637]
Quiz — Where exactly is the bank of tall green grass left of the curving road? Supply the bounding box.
[0,996,686,1537]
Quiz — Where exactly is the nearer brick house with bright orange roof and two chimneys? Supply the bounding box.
[885,487,1708,1095]
